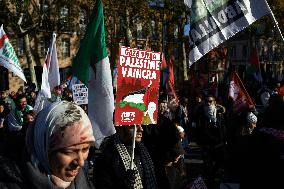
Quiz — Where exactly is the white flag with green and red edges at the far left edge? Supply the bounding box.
[0,25,27,82]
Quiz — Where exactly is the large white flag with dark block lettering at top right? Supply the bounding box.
[189,0,269,66]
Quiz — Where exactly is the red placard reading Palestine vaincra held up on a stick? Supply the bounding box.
[115,47,161,125]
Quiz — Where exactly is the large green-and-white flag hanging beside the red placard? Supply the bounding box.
[72,0,115,147]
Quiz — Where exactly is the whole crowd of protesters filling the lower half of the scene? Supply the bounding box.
[0,78,284,189]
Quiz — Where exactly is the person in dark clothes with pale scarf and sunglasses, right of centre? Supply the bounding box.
[196,95,226,186]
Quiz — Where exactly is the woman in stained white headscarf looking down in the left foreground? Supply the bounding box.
[0,101,95,189]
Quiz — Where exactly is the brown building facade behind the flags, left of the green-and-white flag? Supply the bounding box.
[0,0,93,91]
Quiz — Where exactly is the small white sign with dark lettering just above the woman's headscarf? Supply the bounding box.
[72,84,88,105]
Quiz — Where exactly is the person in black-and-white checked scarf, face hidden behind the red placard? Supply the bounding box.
[93,125,157,189]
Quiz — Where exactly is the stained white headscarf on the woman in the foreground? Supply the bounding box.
[27,101,95,174]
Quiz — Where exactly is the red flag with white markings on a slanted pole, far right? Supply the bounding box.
[229,71,255,112]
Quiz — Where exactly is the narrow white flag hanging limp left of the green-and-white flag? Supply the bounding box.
[34,33,60,112]
